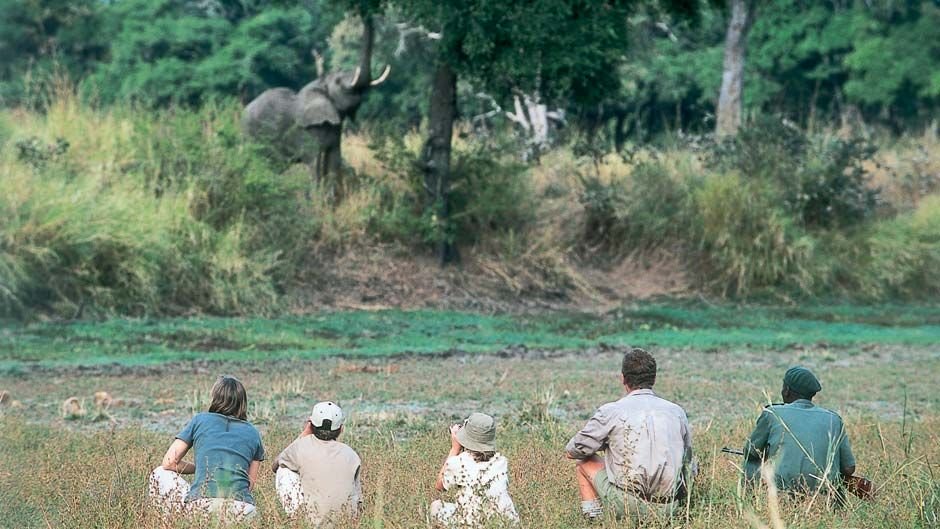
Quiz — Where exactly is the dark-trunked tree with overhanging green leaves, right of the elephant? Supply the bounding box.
[400,0,697,264]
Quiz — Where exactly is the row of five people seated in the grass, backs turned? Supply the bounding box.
[149,348,855,527]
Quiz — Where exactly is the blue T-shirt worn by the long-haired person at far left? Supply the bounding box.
[176,412,264,505]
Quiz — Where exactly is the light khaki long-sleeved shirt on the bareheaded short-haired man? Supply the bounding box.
[565,389,692,501]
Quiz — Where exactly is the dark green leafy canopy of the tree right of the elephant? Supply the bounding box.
[397,0,648,109]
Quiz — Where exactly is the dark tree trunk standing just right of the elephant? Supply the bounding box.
[422,61,459,266]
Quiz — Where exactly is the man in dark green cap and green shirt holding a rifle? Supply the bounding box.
[744,366,855,493]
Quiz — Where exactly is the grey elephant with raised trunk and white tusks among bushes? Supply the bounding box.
[242,17,391,200]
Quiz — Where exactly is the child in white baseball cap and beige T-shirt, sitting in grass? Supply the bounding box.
[273,401,362,526]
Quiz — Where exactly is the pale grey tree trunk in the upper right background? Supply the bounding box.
[715,0,755,137]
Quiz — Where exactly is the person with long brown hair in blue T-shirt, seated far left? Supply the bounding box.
[150,375,264,522]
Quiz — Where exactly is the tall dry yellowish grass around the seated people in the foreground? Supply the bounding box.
[0,418,940,529]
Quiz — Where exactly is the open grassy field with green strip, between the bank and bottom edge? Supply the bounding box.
[0,303,940,529]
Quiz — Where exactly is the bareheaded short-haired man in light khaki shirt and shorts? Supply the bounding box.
[565,348,692,521]
